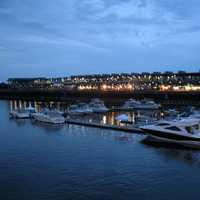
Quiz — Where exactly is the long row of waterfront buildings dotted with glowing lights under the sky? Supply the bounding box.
[8,71,200,91]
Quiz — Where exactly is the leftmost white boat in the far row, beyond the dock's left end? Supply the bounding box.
[68,103,93,114]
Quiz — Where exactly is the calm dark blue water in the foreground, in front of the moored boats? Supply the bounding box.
[0,101,200,200]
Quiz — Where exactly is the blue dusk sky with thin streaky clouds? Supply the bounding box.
[0,0,200,81]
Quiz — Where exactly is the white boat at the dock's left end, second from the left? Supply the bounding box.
[33,111,65,124]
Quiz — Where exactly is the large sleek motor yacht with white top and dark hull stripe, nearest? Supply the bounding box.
[140,117,200,149]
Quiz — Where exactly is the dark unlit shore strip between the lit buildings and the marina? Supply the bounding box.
[0,89,200,106]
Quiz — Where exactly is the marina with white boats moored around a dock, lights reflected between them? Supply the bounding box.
[7,99,200,145]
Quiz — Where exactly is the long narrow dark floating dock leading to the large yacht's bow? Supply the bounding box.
[66,119,144,134]
